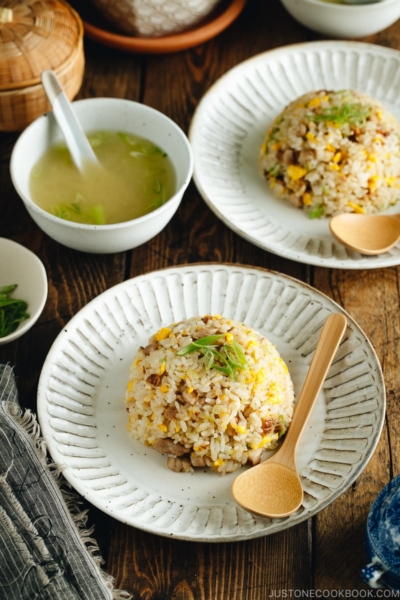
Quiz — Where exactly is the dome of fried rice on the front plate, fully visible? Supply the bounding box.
[126,315,294,474]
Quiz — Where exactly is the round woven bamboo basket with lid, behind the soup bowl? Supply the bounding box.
[0,0,85,131]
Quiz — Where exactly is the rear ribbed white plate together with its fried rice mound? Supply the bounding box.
[189,41,400,269]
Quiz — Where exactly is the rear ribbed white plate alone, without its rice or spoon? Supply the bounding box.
[189,41,400,269]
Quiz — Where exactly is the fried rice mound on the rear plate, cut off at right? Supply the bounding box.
[260,90,400,218]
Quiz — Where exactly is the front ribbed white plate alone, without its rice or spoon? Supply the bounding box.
[38,264,385,541]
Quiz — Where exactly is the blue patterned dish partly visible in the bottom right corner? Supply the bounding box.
[361,476,400,590]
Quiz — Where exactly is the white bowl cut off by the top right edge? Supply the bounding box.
[281,0,400,38]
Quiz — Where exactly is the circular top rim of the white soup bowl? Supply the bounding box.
[10,96,194,231]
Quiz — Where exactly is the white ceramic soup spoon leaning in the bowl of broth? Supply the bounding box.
[41,70,98,171]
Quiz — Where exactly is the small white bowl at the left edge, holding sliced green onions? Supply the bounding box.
[0,238,47,345]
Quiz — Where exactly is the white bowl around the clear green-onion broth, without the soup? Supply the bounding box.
[10,98,193,254]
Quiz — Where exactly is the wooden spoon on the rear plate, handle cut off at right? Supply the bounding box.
[329,213,400,255]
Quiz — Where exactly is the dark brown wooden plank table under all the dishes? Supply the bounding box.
[0,0,400,600]
